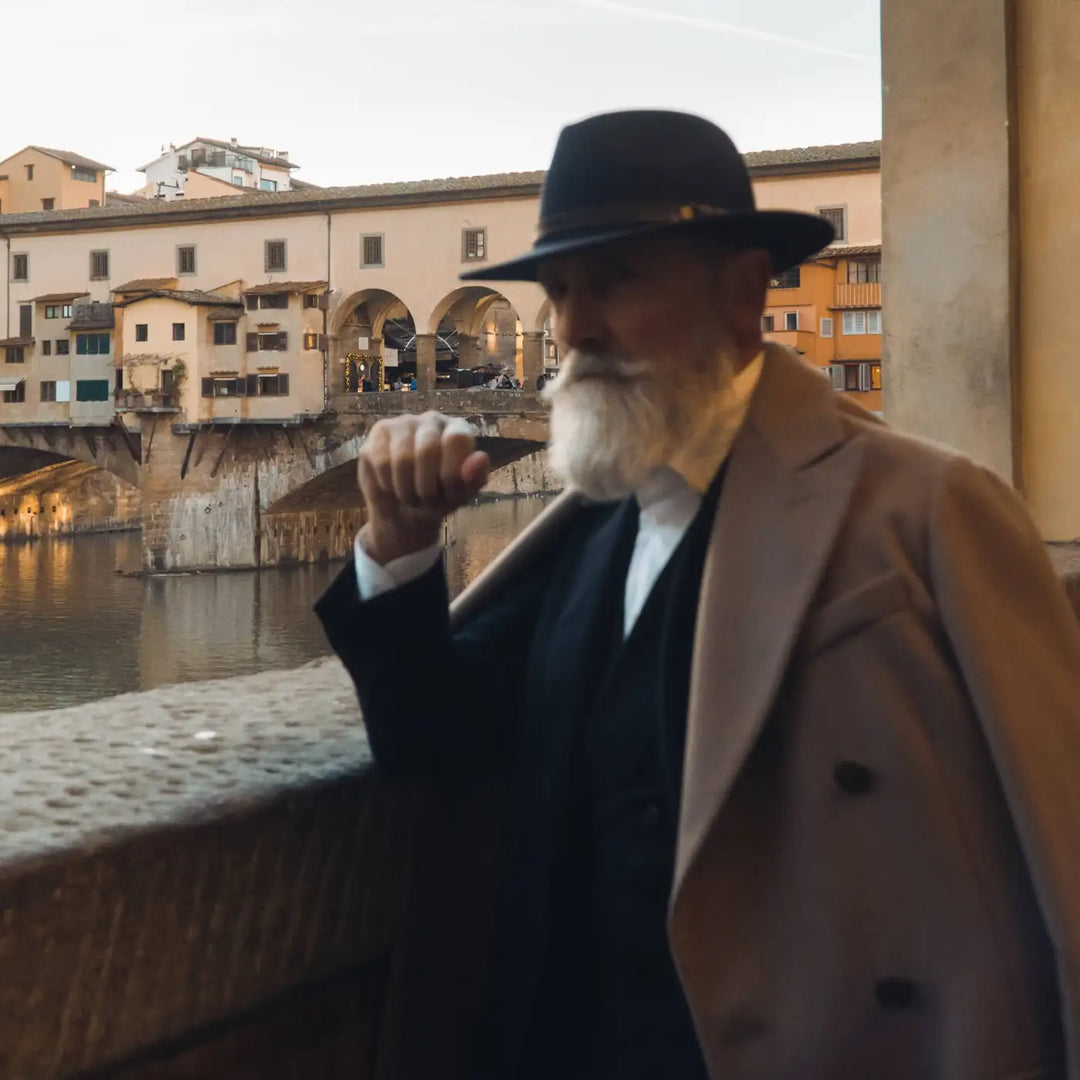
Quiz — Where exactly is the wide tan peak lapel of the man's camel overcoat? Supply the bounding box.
[672,347,862,912]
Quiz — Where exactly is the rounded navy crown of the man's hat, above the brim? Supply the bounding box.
[540,110,755,231]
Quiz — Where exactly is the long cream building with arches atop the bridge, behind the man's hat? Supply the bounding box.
[0,144,881,424]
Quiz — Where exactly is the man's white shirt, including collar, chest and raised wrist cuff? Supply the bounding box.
[354,353,762,635]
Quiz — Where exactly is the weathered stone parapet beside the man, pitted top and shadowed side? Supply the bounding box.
[0,661,496,1080]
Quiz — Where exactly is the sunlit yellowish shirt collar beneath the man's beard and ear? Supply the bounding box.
[635,352,765,512]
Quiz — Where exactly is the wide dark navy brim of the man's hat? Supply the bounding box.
[460,210,836,281]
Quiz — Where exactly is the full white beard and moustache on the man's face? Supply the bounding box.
[543,346,733,501]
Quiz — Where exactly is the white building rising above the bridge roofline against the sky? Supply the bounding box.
[136,138,297,199]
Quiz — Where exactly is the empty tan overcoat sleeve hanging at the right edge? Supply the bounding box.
[930,458,1080,1080]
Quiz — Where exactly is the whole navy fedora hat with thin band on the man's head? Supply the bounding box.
[461,110,834,281]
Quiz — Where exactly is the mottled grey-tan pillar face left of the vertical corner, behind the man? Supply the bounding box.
[881,0,1015,482]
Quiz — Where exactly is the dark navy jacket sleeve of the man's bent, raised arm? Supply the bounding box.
[315,559,542,784]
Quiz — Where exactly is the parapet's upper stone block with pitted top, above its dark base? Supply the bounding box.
[0,660,455,1080]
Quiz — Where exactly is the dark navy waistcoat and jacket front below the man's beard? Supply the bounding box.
[496,477,721,1080]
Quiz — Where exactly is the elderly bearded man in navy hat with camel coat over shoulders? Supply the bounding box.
[320,112,1080,1080]
